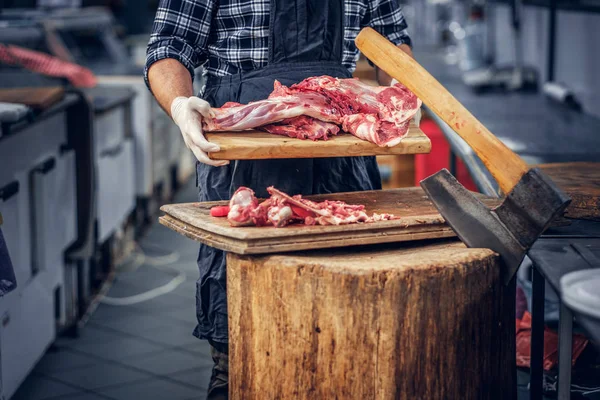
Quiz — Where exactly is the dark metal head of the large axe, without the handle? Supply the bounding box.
[421,168,571,284]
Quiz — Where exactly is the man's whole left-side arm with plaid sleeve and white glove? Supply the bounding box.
[144,0,229,166]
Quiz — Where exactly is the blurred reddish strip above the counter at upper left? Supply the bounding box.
[0,44,97,88]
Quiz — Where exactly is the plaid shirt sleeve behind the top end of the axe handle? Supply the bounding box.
[364,0,412,48]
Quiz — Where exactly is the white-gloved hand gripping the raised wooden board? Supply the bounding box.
[171,96,229,167]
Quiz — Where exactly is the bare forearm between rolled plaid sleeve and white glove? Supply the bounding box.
[148,58,194,118]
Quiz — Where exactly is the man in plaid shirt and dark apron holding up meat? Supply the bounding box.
[144,0,412,399]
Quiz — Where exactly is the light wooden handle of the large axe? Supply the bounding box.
[356,28,529,193]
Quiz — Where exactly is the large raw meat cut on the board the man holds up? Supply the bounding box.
[202,76,422,147]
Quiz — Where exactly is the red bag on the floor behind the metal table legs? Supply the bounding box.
[516,311,588,371]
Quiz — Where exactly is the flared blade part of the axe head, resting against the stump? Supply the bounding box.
[421,169,527,284]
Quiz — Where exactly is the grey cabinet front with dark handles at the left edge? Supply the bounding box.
[0,102,74,398]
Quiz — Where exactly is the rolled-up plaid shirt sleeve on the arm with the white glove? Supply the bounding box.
[144,0,214,88]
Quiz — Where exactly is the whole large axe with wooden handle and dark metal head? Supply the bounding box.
[356,28,571,284]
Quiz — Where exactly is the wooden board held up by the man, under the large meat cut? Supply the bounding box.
[206,124,431,160]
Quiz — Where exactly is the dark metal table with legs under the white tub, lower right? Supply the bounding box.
[529,221,600,400]
